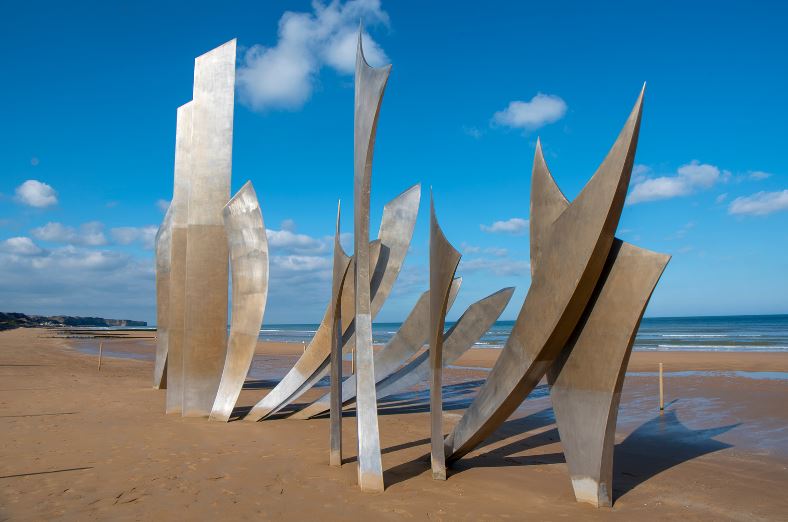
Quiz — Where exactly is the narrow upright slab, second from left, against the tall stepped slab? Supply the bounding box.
[165,102,193,414]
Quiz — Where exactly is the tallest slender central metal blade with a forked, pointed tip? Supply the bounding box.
[353,31,391,491]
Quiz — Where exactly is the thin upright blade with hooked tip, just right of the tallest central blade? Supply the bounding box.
[429,194,462,480]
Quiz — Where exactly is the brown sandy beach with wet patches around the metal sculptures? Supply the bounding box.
[0,329,788,520]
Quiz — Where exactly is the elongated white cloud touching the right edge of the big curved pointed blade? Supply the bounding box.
[627,160,731,205]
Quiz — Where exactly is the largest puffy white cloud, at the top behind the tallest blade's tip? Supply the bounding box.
[236,0,389,110]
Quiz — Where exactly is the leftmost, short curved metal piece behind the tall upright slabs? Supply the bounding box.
[153,202,172,390]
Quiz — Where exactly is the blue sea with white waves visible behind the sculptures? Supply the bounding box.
[260,315,788,352]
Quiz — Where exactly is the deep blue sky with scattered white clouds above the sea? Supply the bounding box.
[0,0,788,323]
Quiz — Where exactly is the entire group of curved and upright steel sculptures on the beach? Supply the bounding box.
[154,31,669,506]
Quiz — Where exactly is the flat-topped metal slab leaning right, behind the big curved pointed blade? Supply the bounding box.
[547,240,670,507]
